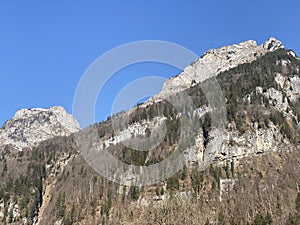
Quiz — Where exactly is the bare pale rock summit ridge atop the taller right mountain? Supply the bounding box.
[152,37,284,99]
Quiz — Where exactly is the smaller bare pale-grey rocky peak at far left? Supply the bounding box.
[0,106,80,150]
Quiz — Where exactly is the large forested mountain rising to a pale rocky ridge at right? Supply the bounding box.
[0,38,300,225]
